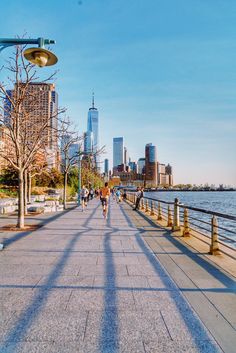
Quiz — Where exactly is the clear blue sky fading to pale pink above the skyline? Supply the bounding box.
[0,0,236,185]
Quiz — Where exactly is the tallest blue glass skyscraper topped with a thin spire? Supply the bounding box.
[87,93,100,170]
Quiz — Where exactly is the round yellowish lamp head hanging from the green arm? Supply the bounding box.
[24,47,58,67]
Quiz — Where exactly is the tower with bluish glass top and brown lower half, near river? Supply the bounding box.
[145,143,157,186]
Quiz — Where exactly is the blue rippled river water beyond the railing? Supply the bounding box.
[145,191,236,247]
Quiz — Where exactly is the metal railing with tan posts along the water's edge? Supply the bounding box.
[127,192,236,257]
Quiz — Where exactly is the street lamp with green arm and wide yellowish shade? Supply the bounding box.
[0,38,58,67]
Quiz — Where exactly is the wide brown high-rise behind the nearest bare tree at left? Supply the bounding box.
[4,82,58,167]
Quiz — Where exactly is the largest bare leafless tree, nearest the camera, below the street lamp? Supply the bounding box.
[0,46,64,228]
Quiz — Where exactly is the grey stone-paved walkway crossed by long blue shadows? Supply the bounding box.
[0,200,236,353]
